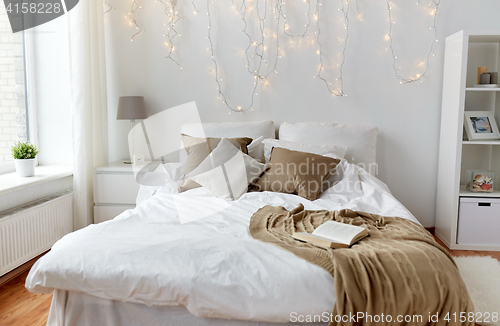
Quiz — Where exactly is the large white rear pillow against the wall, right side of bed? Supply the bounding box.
[279,122,378,174]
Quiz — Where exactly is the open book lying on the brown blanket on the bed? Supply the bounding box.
[292,221,368,248]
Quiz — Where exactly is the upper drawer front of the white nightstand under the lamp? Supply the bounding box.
[94,173,139,205]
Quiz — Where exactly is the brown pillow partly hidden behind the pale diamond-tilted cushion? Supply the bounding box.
[179,134,252,192]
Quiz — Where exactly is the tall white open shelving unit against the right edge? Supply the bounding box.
[436,30,500,251]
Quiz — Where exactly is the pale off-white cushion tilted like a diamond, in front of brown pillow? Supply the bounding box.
[186,138,266,200]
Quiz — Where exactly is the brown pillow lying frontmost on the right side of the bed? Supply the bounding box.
[252,147,340,200]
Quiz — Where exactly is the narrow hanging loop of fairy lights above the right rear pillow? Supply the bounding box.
[314,0,349,96]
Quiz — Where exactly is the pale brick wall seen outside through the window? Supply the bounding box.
[0,3,27,163]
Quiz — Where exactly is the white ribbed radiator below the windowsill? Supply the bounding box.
[0,192,73,276]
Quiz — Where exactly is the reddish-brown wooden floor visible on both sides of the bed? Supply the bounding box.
[0,238,500,326]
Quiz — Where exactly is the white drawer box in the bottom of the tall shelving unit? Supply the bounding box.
[457,197,500,245]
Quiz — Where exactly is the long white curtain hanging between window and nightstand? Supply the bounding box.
[67,0,108,230]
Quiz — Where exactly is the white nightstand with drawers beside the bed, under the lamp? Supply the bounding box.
[94,160,139,223]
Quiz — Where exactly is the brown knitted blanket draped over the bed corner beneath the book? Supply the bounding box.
[249,204,474,325]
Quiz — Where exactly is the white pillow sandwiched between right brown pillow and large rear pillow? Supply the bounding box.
[262,139,347,163]
